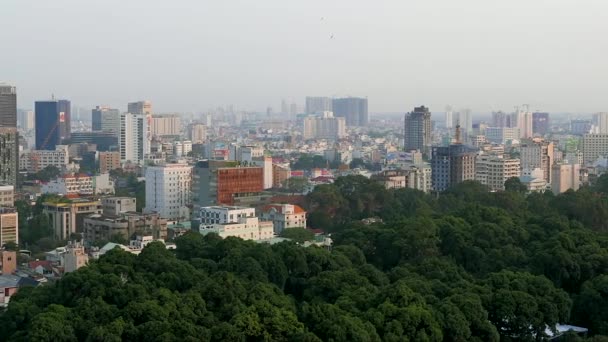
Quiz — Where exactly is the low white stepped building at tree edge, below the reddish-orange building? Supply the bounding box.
[199,206,274,241]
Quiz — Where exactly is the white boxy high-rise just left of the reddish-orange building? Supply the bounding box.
[144,164,192,221]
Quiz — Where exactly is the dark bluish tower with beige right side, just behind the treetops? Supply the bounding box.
[431,144,477,191]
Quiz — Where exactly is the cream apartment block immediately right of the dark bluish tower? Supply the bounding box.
[475,154,521,191]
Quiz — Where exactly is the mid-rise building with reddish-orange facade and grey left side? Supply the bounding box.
[192,160,264,210]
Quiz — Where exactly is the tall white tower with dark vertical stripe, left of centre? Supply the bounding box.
[118,113,152,164]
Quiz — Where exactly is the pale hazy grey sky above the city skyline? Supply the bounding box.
[0,0,608,112]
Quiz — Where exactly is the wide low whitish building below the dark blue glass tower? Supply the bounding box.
[41,173,114,195]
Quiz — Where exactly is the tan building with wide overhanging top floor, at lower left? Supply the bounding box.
[42,198,102,240]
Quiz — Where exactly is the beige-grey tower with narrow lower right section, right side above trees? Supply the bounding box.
[519,139,554,184]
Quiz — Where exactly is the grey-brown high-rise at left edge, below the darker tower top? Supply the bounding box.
[0,127,19,187]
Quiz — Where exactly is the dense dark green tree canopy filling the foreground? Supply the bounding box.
[0,177,608,341]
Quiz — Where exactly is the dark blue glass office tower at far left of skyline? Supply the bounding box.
[35,100,71,150]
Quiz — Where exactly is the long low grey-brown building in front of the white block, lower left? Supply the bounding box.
[83,211,167,242]
